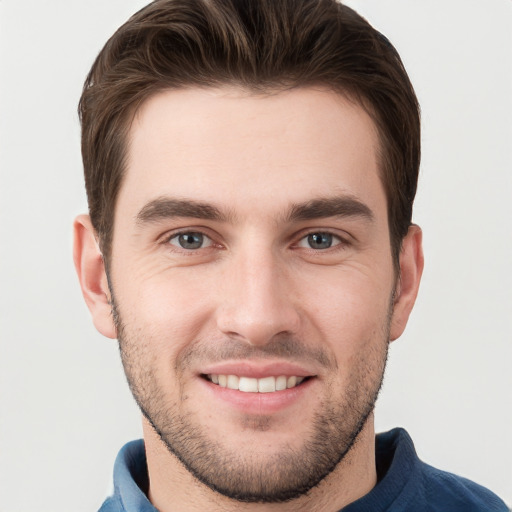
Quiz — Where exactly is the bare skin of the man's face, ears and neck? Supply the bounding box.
[75,87,423,512]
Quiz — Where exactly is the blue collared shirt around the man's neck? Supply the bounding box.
[99,428,509,512]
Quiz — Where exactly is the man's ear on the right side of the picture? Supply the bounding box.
[390,224,423,341]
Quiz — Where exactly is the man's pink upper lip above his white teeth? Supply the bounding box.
[200,361,315,379]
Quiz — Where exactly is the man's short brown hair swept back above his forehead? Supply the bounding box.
[79,0,420,263]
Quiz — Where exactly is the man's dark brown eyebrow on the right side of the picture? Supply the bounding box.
[288,196,374,222]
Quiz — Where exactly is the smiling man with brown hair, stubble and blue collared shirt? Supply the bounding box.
[75,0,506,512]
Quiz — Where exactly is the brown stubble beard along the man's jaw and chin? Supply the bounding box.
[112,299,390,503]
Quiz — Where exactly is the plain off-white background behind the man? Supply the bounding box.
[0,0,512,512]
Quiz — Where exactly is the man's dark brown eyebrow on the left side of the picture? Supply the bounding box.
[136,197,228,224]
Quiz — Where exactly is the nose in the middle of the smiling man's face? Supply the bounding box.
[217,246,301,346]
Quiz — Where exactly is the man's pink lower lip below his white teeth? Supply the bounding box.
[200,377,316,415]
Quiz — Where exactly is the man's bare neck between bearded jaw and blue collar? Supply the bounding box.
[143,414,377,512]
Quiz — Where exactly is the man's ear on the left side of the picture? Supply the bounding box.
[73,215,117,339]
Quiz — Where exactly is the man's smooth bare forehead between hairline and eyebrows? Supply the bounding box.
[118,87,383,222]
